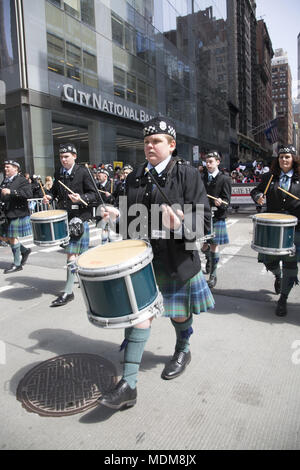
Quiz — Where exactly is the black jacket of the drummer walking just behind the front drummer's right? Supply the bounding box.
[202,171,231,220]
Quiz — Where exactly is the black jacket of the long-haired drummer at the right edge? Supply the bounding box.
[250,173,300,230]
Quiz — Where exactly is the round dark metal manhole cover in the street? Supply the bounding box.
[17,354,117,416]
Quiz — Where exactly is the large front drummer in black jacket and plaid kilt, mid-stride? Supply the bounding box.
[99,116,214,409]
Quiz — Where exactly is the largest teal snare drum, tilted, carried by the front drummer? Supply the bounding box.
[77,240,163,328]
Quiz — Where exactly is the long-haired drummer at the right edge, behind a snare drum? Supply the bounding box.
[250,145,300,317]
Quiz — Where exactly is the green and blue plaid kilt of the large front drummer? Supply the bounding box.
[153,262,215,318]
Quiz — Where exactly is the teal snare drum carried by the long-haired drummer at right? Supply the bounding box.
[251,212,298,255]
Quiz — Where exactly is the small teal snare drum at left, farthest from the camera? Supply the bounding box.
[30,210,70,246]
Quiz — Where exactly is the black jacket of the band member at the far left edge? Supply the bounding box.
[0,174,32,219]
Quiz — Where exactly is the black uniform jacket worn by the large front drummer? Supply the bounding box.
[121,157,210,283]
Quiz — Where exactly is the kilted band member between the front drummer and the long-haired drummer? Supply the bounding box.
[202,151,231,289]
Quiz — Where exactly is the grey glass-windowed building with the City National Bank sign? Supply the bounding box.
[0,0,228,176]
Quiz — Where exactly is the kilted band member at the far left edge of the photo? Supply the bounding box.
[0,160,32,274]
